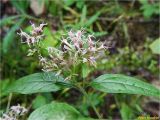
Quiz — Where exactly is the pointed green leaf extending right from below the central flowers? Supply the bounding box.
[91,74,160,97]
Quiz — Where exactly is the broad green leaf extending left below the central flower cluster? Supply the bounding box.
[7,72,64,94]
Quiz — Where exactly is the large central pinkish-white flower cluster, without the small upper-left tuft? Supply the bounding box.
[40,30,107,72]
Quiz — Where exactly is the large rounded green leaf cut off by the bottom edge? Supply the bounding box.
[28,102,91,120]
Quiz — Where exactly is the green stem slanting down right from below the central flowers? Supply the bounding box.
[78,86,102,119]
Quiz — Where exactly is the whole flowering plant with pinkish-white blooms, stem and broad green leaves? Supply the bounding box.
[4,23,160,120]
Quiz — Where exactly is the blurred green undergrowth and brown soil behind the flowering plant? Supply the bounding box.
[0,0,160,120]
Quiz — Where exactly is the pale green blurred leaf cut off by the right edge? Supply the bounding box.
[150,38,160,54]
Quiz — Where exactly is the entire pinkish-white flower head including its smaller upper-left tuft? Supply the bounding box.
[18,23,107,79]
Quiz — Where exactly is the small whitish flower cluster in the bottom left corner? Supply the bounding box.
[0,104,27,120]
